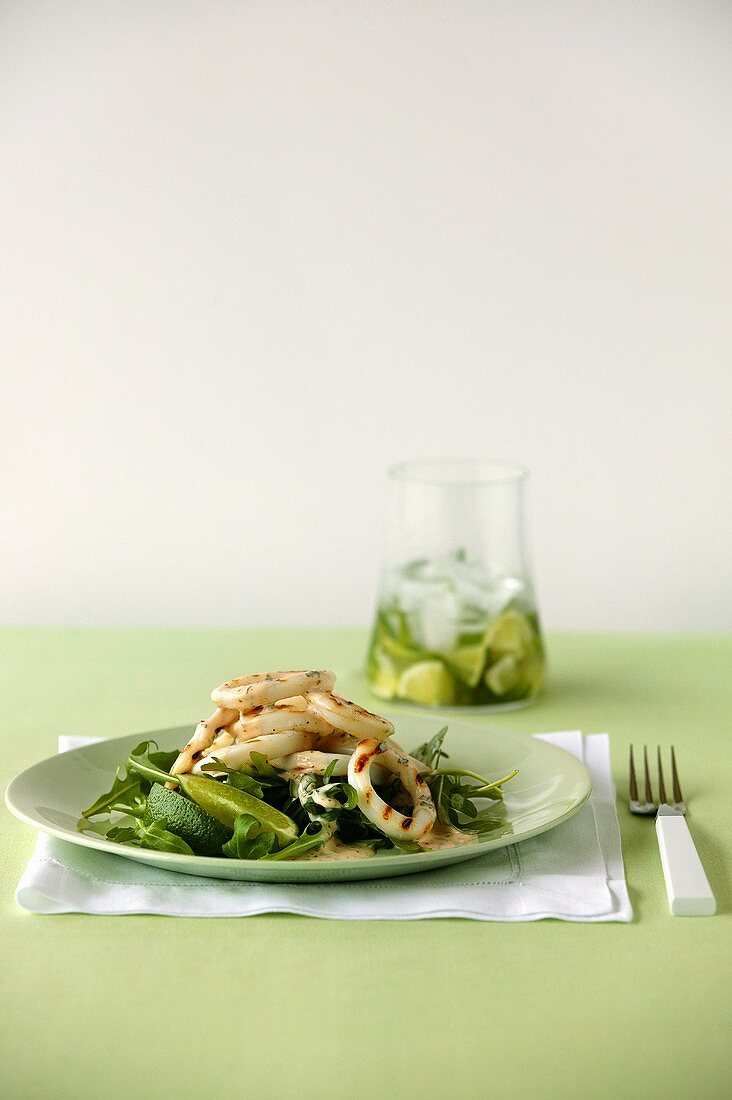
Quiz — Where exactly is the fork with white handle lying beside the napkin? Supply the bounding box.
[629,745,717,916]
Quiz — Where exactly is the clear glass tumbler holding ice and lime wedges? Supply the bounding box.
[367,459,546,711]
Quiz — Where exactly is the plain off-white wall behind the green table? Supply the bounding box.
[0,0,732,630]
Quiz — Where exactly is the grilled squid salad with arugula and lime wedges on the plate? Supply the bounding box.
[78,670,517,860]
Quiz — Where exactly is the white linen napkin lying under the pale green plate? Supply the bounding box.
[15,730,633,921]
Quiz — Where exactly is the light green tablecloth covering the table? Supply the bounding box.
[0,629,732,1100]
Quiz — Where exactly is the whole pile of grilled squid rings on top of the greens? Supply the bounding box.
[171,670,437,840]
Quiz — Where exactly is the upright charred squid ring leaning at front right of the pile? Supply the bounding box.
[348,737,437,840]
